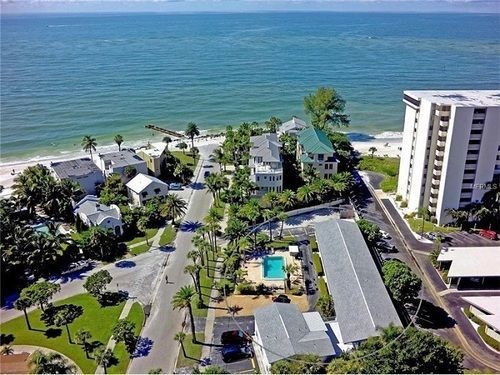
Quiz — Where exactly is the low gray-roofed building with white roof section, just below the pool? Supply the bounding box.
[254,302,336,374]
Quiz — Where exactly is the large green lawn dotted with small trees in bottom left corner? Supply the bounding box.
[0,294,124,374]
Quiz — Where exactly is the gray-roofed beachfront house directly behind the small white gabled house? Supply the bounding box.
[97,149,148,182]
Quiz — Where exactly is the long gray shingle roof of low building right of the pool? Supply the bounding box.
[316,220,401,343]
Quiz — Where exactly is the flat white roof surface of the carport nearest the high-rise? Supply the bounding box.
[437,246,500,279]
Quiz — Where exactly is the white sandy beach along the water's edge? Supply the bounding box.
[0,130,402,197]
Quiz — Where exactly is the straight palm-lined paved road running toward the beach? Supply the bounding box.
[128,146,218,374]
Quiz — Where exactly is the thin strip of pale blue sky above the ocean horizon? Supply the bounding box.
[0,0,500,14]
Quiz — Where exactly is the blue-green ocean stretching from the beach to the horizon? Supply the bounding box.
[0,12,500,163]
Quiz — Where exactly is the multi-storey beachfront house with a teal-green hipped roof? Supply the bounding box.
[297,127,338,178]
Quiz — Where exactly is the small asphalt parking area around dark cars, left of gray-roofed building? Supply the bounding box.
[210,316,257,374]
